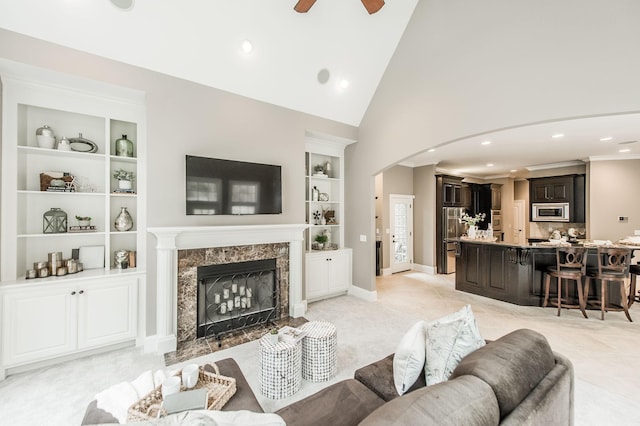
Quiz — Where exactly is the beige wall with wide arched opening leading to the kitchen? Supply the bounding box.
[346,0,640,290]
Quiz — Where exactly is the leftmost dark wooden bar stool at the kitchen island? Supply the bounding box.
[542,247,589,318]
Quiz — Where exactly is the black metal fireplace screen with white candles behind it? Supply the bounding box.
[197,259,280,338]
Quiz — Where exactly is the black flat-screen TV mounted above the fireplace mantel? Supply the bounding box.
[186,155,282,215]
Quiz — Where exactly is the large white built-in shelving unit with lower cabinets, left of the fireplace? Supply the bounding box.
[0,60,146,377]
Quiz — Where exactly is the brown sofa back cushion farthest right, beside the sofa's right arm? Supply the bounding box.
[451,329,555,418]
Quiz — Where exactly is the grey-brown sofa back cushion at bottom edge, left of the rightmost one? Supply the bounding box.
[360,376,500,426]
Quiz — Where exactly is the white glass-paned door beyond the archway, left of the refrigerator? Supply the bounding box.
[389,194,413,273]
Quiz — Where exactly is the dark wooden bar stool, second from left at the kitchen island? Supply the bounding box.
[584,247,633,322]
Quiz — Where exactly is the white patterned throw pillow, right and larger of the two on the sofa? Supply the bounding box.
[424,305,485,386]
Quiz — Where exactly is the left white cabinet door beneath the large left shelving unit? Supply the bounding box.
[2,286,78,365]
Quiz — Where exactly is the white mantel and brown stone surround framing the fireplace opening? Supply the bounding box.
[150,224,308,353]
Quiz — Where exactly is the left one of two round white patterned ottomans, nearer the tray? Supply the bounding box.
[258,335,302,399]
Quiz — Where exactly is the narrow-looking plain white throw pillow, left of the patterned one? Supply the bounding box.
[393,321,426,395]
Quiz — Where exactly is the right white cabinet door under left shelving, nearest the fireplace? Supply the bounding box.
[78,278,138,349]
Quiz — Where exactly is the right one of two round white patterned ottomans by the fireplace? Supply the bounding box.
[300,321,338,382]
